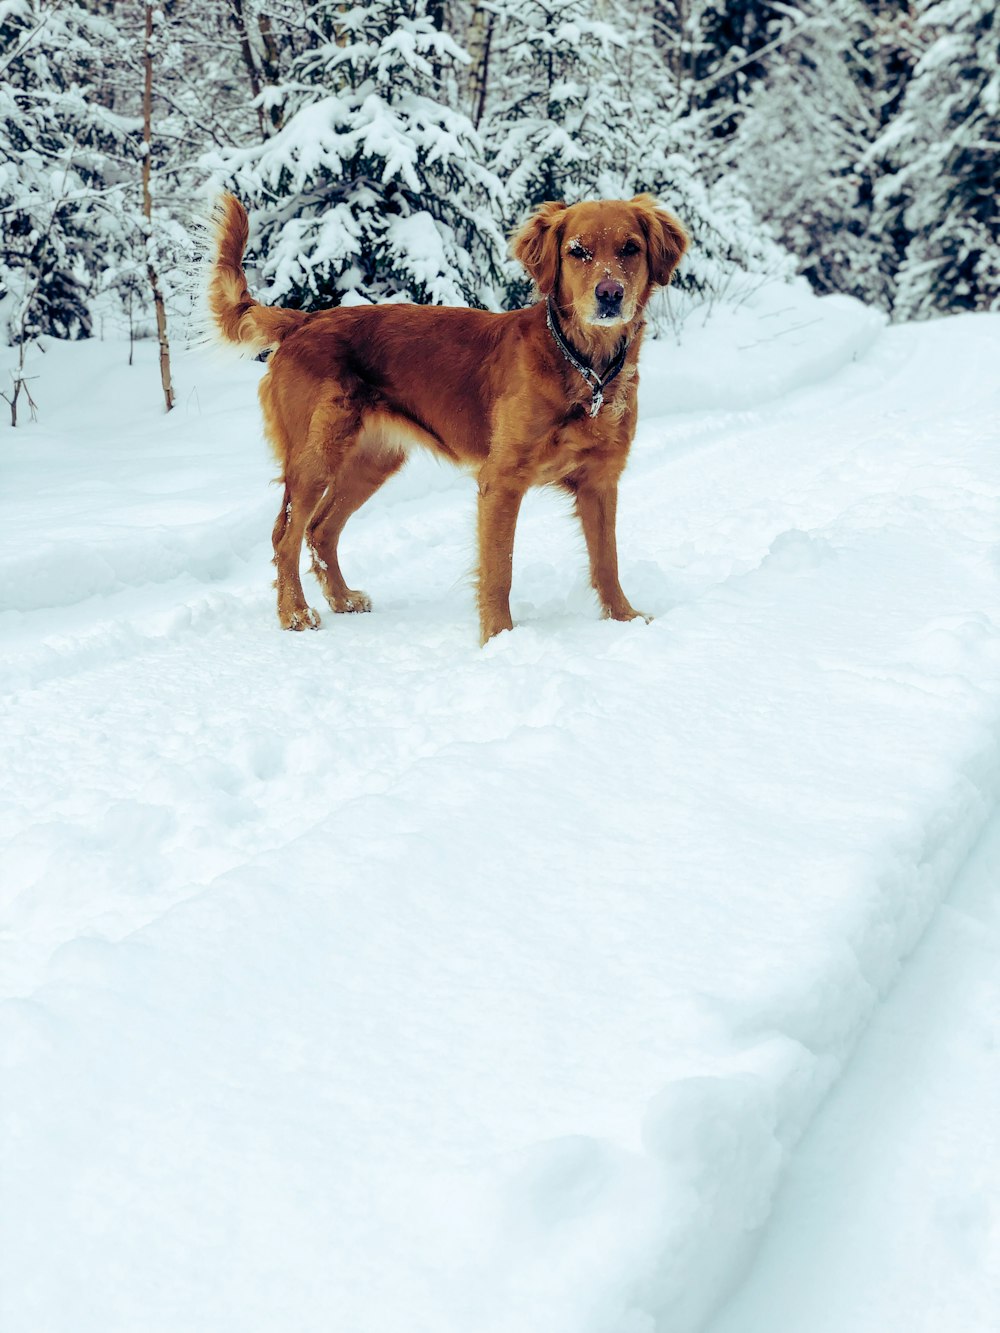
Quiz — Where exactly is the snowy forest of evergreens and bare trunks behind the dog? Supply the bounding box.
[0,0,1000,357]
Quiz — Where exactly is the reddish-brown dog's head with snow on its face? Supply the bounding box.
[512,195,688,327]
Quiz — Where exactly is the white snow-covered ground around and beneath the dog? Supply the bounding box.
[0,287,1000,1333]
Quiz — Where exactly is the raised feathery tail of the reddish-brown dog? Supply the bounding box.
[207,195,305,356]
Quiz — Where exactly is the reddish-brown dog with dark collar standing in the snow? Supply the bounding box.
[208,195,687,643]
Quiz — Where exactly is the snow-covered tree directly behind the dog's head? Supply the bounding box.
[480,0,787,301]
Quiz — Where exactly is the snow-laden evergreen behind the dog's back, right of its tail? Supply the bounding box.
[216,0,503,307]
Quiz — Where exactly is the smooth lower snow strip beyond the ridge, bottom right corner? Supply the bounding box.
[709,816,1000,1333]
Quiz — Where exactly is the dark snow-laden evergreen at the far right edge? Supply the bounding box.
[875,0,1000,319]
